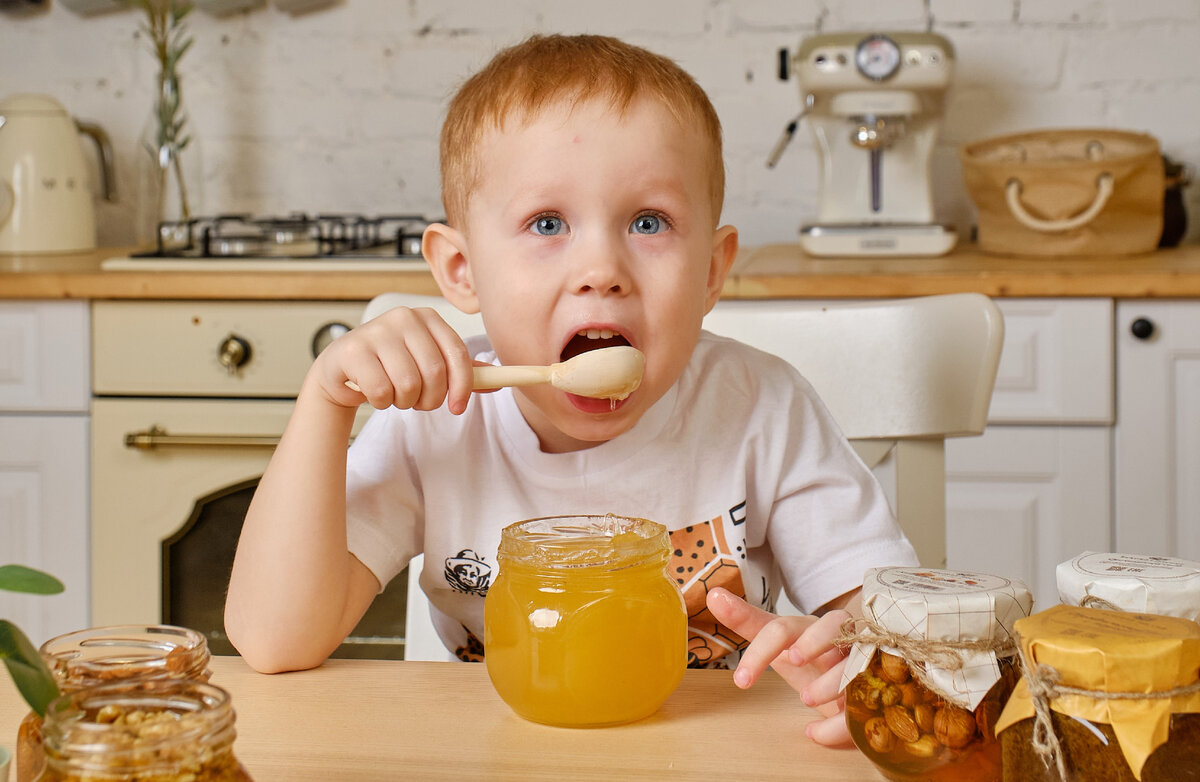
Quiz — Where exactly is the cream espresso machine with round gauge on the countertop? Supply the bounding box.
[768,32,956,257]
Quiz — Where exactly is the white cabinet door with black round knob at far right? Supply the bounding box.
[1114,300,1200,561]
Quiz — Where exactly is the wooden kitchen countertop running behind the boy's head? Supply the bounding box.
[0,245,1200,301]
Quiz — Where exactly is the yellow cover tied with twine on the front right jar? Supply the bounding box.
[996,606,1200,782]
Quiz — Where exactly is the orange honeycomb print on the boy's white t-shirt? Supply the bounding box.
[667,504,746,668]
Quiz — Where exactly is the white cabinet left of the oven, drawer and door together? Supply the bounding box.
[0,300,90,644]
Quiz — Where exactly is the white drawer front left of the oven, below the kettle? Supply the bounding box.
[0,301,91,413]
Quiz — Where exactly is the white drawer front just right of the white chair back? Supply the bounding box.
[988,299,1115,425]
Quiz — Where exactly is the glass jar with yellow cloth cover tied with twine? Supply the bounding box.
[997,606,1200,782]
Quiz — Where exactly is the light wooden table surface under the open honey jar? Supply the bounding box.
[0,657,883,782]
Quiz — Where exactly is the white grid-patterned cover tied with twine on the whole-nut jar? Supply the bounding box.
[841,567,1033,710]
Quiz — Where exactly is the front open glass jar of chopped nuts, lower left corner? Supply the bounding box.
[37,679,251,782]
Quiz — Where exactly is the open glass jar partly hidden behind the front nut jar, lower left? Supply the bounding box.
[17,625,210,782]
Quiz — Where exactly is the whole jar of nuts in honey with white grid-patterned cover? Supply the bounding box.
[842,567,1033,782]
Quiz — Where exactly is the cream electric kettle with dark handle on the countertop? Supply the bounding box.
[0,95,116,254]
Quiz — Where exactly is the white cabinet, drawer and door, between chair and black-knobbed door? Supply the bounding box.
[946,299,1113,606]
